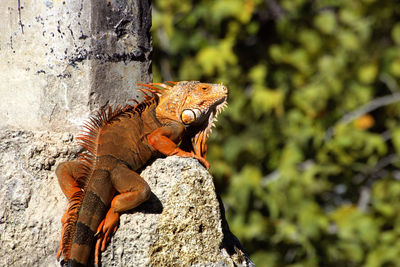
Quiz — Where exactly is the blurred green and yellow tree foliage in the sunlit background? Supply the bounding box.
[152,0,400,267]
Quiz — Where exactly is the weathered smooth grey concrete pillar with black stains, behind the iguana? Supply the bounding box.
[0,0,152,132]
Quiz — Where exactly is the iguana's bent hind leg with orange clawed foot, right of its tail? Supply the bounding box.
[95,164,151,264]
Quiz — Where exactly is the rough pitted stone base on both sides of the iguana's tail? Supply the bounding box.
[0,130,252,266]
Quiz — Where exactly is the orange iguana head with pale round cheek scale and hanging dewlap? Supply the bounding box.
[141,81,228,158]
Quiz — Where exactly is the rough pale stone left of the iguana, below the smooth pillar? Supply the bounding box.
[0,131,78,266]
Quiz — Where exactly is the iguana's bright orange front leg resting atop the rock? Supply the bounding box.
[147,123,210,169]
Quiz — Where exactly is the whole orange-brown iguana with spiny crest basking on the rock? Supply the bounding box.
[56,81,228,266]
